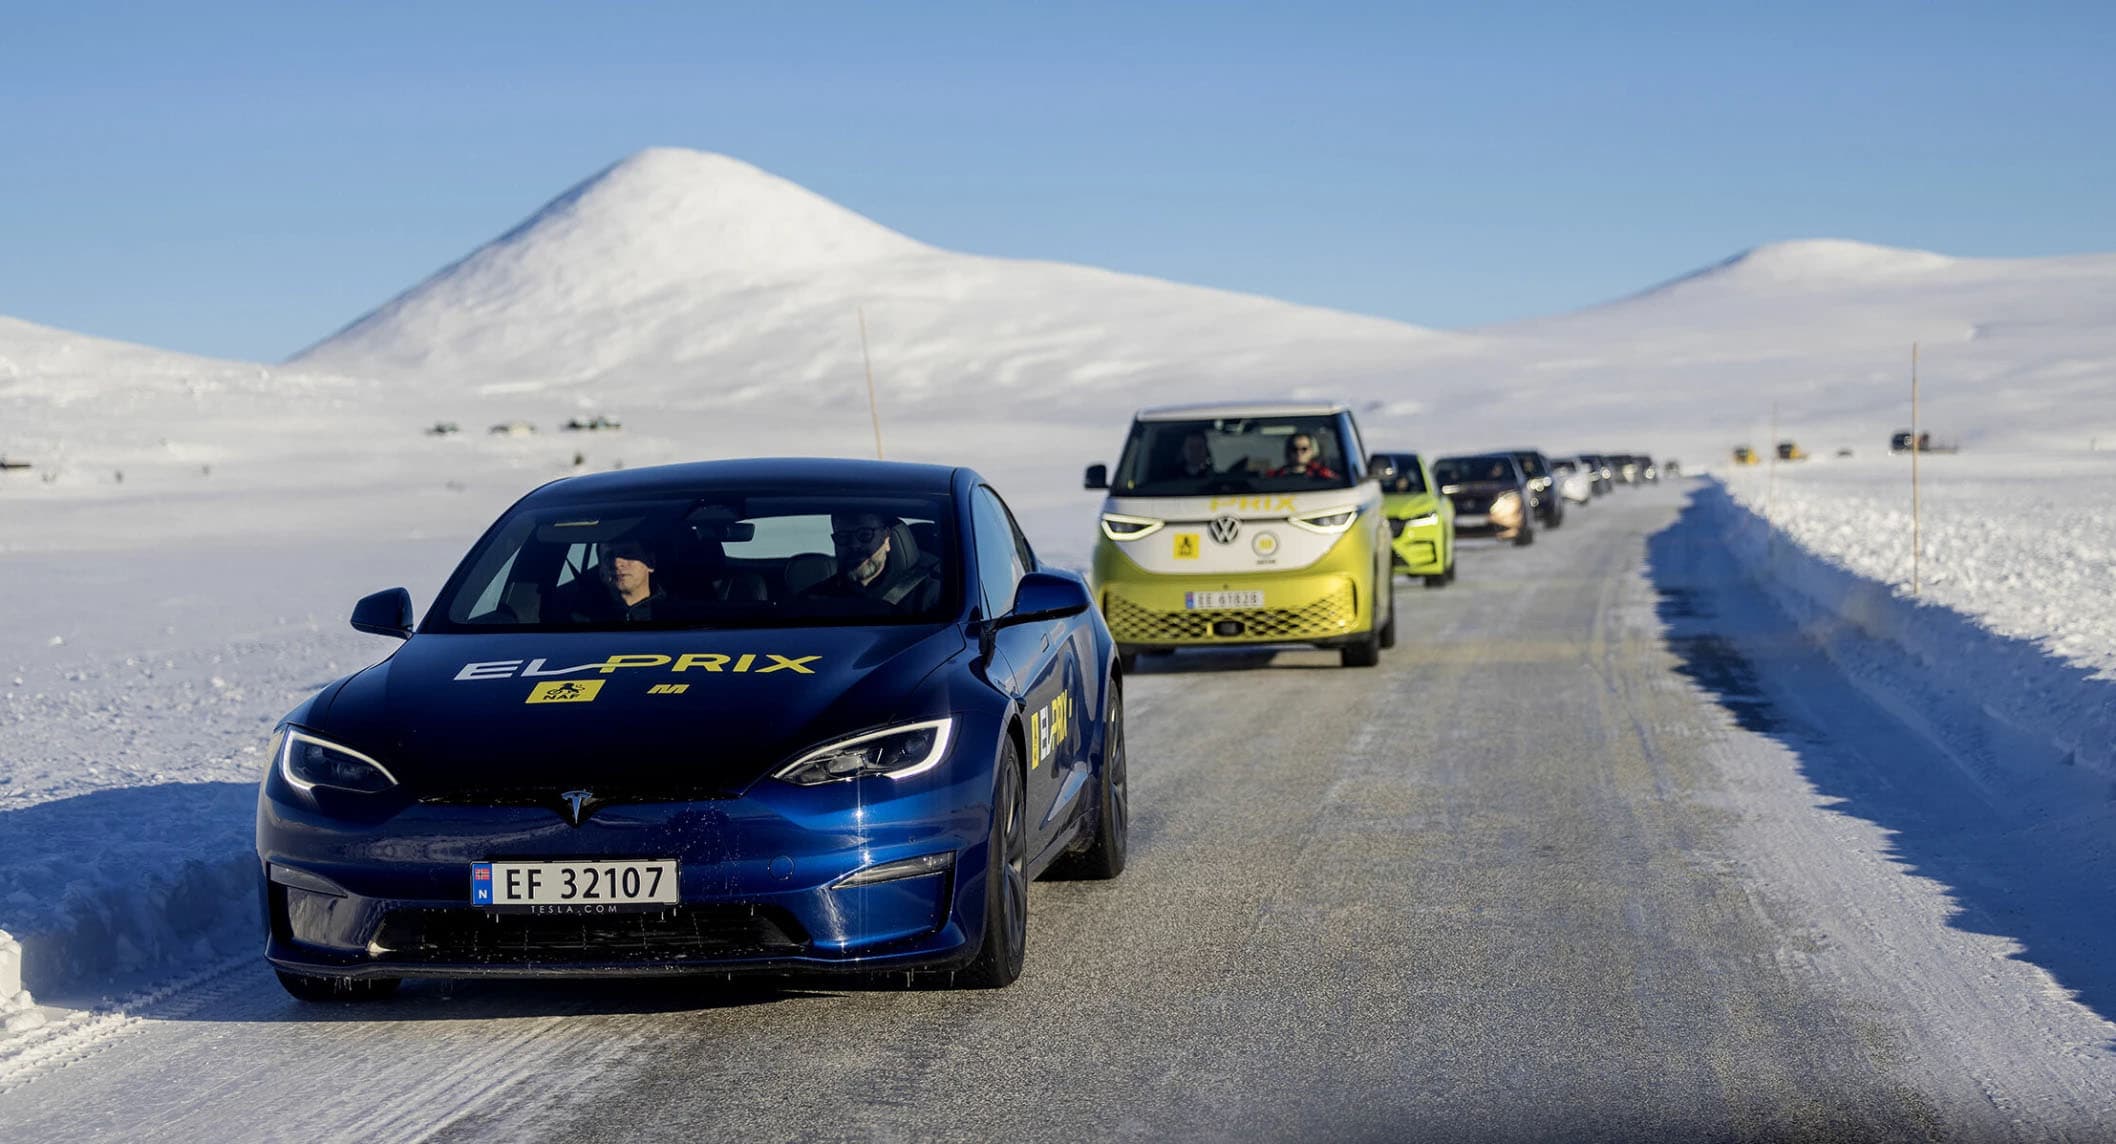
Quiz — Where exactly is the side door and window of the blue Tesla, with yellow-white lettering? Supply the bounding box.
[971,484,1083,850]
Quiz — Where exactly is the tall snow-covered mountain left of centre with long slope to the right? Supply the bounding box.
[294,148,1466,417]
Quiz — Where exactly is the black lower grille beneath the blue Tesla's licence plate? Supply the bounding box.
[370,905,806,964]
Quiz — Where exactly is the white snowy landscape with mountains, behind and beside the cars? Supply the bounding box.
[0,150,2116,1028]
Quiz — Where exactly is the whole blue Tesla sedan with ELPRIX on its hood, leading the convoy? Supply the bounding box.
[256,461,1128,1000]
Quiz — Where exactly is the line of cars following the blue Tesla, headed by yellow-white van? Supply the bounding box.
[1083,402,1659,670]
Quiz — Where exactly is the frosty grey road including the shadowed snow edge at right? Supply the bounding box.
[0,486,2116,1142]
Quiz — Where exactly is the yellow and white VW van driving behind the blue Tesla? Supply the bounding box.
[1088,402,1397,670]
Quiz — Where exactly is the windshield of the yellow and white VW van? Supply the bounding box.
[1111,414,1352,497]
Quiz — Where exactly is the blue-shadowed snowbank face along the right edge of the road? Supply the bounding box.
[1697,478,2116,778]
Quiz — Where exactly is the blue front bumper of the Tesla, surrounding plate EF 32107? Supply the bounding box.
[258,765,990,977]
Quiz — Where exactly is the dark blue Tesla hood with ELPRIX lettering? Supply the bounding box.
[309,624,965,799]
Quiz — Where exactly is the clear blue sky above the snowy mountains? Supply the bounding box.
[0,0,2116,359]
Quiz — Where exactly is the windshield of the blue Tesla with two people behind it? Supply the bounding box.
[425,491,961,632]
